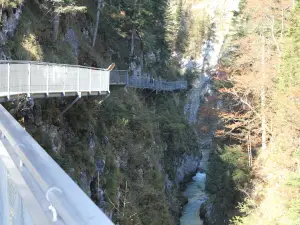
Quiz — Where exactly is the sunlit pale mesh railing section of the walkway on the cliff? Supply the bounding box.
[0,61,110,99]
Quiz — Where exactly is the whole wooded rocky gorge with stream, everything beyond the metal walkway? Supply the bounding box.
[0,0,300,225]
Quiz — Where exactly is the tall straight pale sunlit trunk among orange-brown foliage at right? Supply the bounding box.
[260,34,267,150]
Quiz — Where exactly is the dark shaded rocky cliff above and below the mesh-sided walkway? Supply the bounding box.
[2,1,206,224]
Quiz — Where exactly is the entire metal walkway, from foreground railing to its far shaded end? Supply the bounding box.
[0,61,187,225]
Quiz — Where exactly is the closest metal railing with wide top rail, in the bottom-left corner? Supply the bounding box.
[0,105,113,225]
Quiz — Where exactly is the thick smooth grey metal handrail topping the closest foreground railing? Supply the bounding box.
[0,105,113,225]
